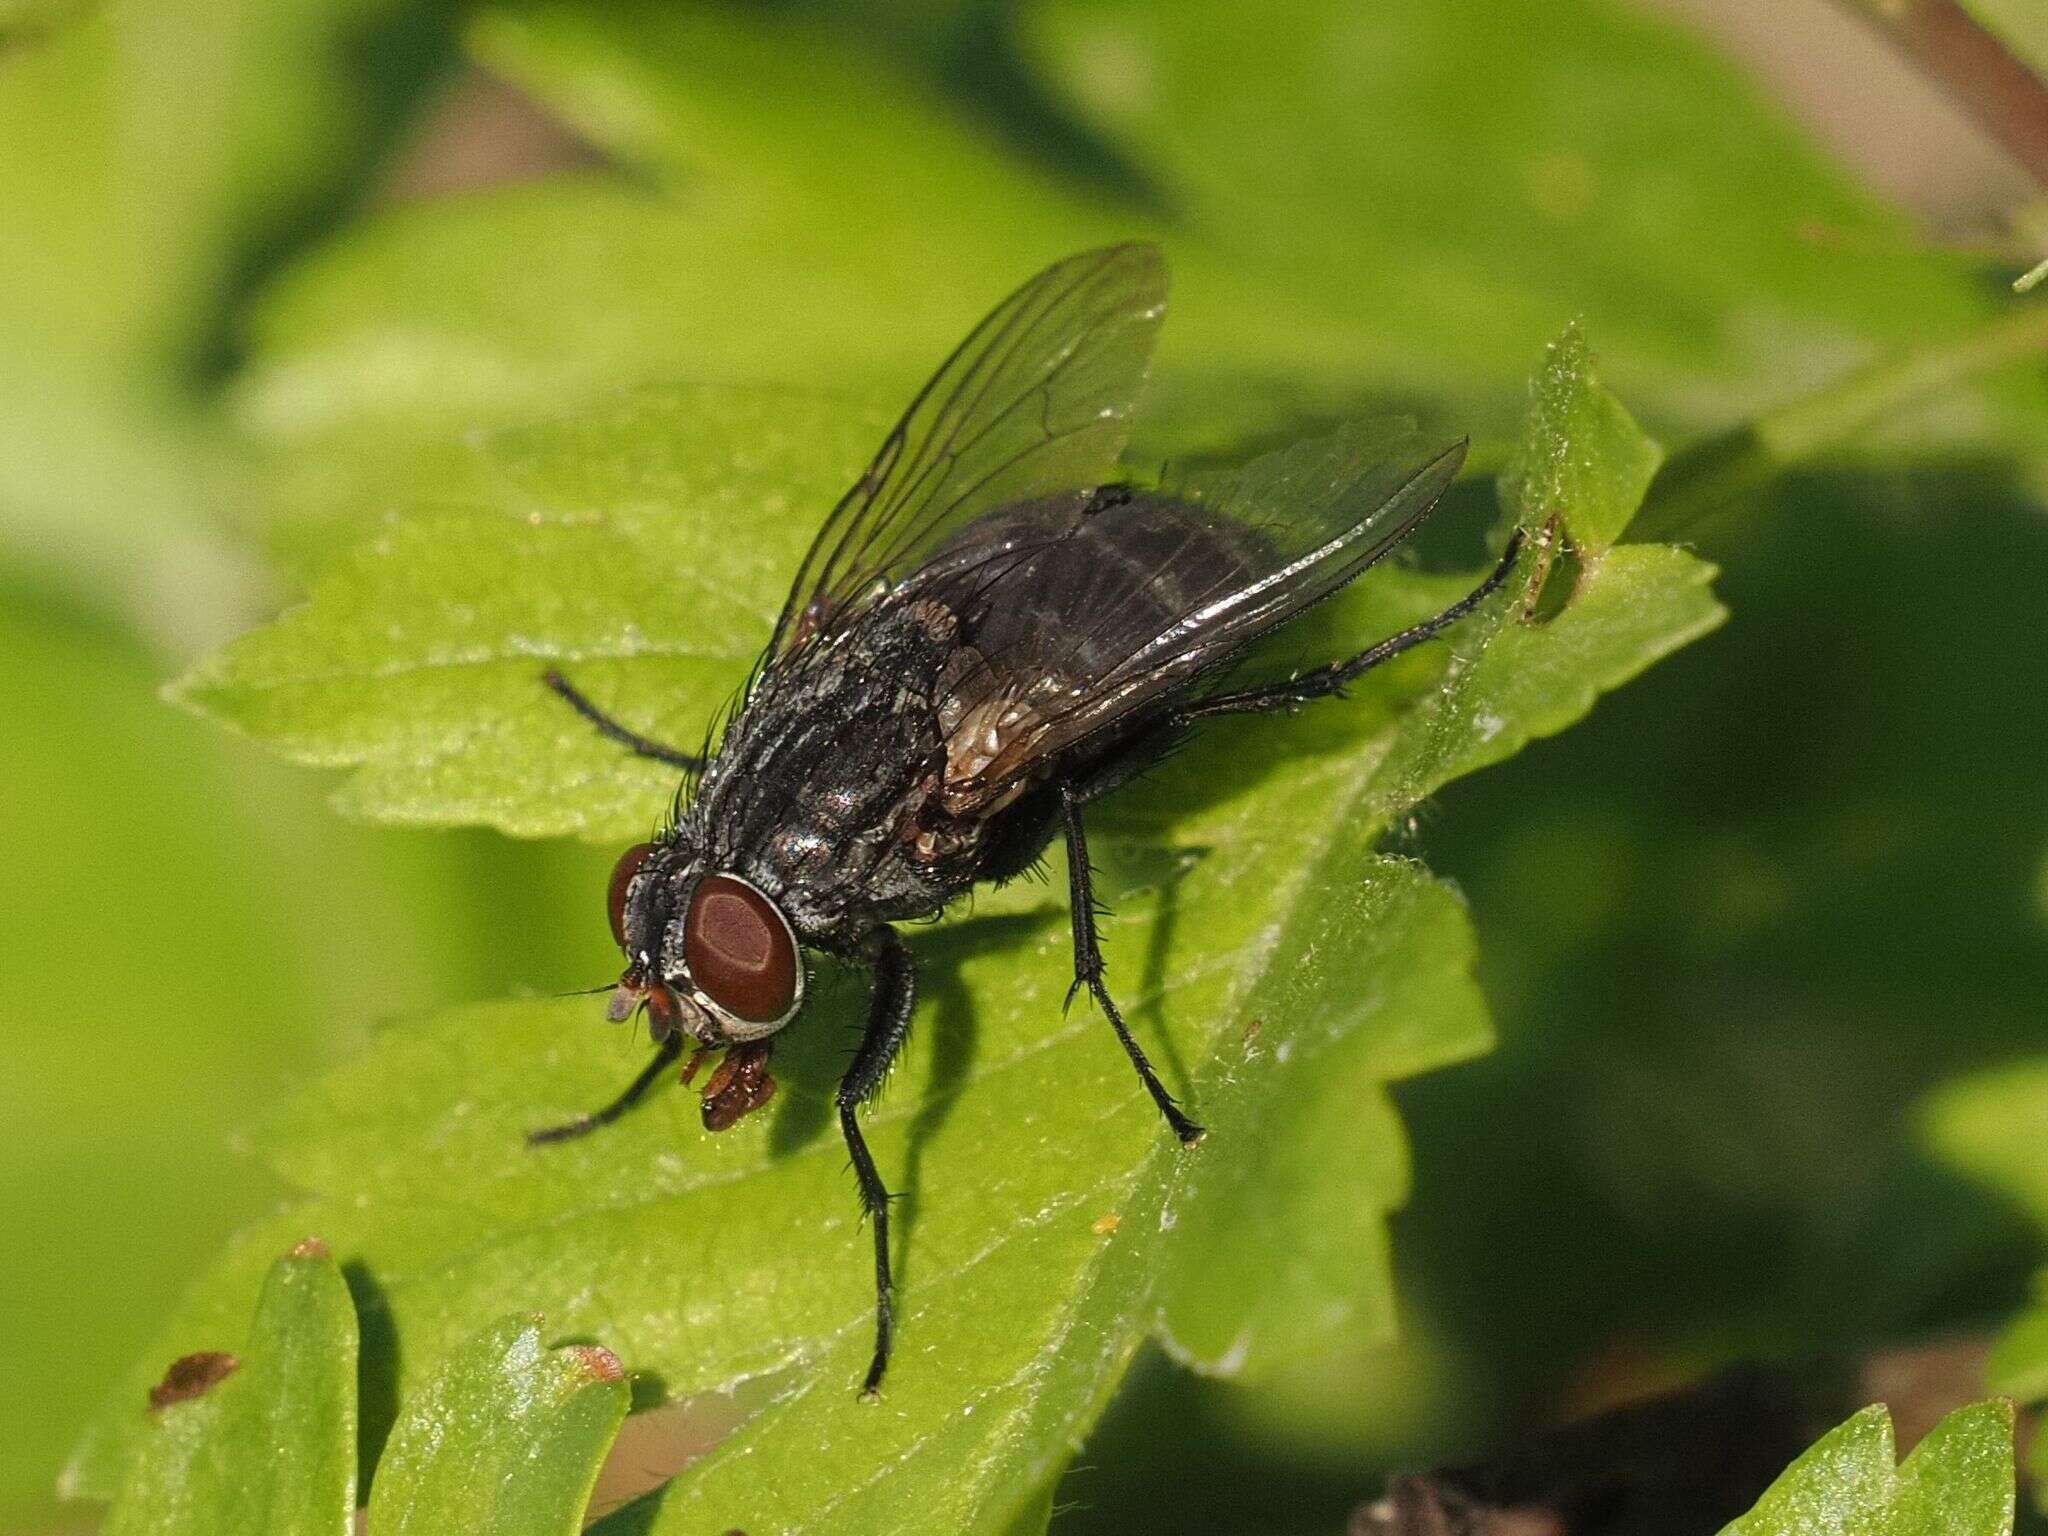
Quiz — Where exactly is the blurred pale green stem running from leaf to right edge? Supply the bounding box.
[1628,303,2048,541]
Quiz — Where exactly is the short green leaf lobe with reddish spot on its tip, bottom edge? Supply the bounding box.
[369,1317,631,1536]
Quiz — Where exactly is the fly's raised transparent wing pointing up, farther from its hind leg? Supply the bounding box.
[768,244,1165,666]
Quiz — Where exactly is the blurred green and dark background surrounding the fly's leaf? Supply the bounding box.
[0,0,2048,1532]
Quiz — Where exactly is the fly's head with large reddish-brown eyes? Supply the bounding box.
[608,840,803,1044]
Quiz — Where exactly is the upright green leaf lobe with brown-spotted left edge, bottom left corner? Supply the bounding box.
[106,1241,356,1536]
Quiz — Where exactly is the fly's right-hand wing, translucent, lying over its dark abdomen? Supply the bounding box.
[913,422,1464,815]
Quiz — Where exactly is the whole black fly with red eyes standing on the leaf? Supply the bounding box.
[532,246,1520,1393]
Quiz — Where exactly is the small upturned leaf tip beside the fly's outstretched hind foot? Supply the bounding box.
[1501,326,1663,551]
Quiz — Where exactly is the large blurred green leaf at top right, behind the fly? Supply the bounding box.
[1024,0,2038,450]
